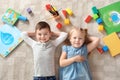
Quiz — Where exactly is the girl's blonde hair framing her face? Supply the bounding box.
[64,27,91,45]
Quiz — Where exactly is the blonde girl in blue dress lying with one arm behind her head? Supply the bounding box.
[60,28,99,80]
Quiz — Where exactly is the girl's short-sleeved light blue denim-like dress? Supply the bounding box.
[60,45,92,80]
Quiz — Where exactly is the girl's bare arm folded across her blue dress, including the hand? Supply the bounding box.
[60,52,85,67]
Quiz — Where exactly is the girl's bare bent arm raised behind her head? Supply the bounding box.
[87,36,100,53]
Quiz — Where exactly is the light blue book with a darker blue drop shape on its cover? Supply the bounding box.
[0,24,23,57]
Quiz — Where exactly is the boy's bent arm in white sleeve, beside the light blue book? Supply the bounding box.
[21,32,35,46]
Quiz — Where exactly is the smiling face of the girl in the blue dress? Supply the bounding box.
[70,31,85,48]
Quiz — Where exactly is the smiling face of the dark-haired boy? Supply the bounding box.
[36,28,51,43]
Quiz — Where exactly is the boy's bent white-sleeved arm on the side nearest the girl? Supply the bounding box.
[52,32,68,46]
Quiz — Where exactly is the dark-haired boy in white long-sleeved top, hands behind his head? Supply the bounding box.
[22,21,67,80]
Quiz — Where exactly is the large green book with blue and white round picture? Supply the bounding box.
[99,1,120,34]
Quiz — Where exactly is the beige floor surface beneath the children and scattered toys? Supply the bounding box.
[0,0,120,80]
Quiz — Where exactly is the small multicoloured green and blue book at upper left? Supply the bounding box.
[2,8,20,25]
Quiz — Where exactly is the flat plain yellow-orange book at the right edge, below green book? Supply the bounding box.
[103,32,120,57]
